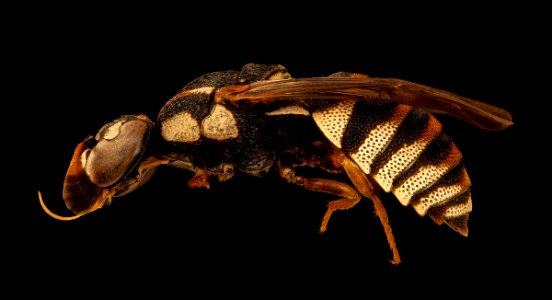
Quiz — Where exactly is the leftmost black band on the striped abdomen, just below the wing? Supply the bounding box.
[341,100,397,153]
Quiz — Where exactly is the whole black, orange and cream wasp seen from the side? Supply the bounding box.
[38,63,513,264]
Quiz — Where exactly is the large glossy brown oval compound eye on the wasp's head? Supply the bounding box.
[81,115,151,188]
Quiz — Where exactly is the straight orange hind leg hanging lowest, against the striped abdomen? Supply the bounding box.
[342,157,401,265]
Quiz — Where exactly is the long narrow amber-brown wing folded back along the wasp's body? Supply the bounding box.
[215,76,513,130]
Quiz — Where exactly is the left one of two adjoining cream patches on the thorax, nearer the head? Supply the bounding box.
[161,112,200,143]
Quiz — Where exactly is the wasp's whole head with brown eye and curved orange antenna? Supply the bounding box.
[39,115,159,220]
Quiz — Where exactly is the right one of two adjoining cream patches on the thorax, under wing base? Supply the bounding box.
[201,104,238,140]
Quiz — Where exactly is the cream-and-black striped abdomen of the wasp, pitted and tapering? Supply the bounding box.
[312,100,472,235]
